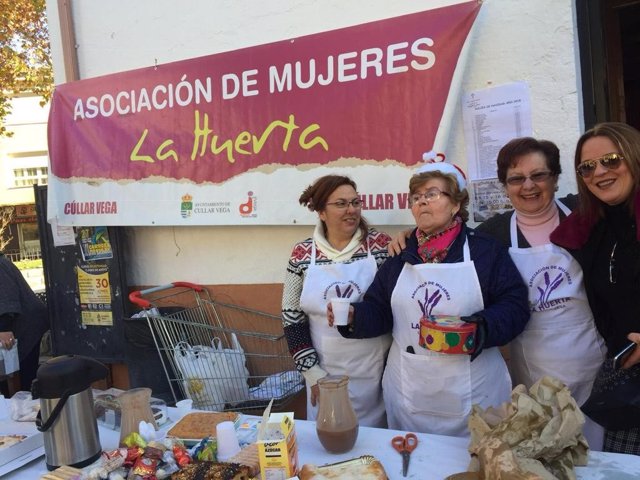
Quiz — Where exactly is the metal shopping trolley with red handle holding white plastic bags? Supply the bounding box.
[129,282,303,411]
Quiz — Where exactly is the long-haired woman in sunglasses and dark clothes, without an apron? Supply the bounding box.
[551,122,640,455]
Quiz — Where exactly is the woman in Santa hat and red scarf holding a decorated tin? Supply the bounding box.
[328,162,529,436]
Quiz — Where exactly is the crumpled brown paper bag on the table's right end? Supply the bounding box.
[450,377,589,480]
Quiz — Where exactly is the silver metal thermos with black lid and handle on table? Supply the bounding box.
[31,355,108,470]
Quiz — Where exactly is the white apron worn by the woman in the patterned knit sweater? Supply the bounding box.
[300,242,391,428]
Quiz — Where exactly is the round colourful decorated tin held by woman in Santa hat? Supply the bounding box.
[419,315,476,355]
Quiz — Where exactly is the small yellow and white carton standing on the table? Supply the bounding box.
[257,412,298,480]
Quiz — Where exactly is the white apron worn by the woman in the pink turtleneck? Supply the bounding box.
[509,200,606,450]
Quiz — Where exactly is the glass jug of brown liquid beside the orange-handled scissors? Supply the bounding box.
[316,375,358,453]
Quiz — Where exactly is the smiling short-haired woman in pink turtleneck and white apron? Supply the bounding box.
[477,137,606,450]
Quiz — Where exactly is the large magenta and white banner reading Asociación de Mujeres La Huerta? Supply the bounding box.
[48,0,480,226]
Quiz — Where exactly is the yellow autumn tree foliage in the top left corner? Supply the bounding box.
[0,0,53,136]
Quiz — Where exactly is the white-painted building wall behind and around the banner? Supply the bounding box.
[47,0,582,296]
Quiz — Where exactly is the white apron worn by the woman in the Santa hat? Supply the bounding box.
[382,241,511,436]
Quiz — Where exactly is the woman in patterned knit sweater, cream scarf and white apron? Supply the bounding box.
[282,175,391,427]
